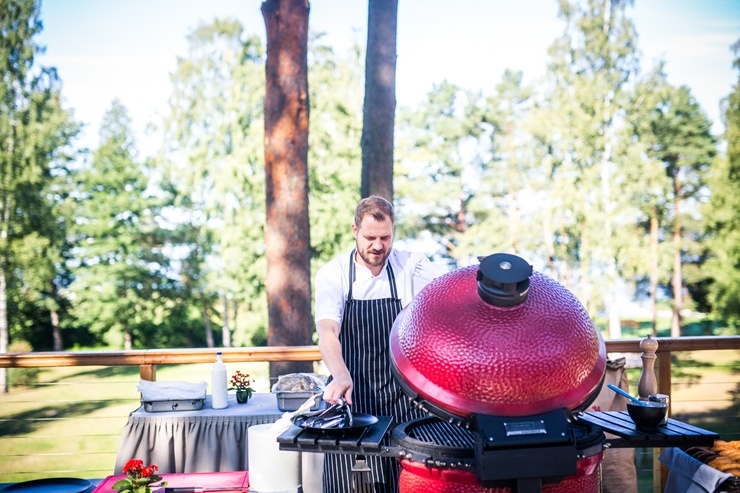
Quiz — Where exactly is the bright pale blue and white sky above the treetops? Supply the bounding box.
[38,0,740,147]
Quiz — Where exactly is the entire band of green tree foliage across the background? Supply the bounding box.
[0,0,740,349]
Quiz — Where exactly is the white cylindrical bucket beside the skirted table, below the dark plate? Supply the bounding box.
[247,423,301,493]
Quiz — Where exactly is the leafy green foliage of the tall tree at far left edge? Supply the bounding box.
[0,0,79,348]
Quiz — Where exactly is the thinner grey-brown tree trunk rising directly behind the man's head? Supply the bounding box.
[360,0,398,202]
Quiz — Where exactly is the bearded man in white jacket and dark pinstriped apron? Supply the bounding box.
[314,196,445,493]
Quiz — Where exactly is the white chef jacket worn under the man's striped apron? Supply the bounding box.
[314,248,446,327]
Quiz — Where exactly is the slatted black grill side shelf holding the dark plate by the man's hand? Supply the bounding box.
[277,416,391,455]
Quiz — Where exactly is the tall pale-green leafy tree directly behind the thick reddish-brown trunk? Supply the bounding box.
[160,25,362,345]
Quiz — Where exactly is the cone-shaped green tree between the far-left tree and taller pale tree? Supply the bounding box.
[71,101,172,347]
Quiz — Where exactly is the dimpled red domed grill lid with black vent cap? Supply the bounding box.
[390,253,606,419]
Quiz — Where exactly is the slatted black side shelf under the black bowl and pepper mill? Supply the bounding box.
[577,411,719,448]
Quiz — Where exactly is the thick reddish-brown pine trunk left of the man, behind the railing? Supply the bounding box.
[262,0,313,379]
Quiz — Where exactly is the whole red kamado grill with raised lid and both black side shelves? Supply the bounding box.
[278,253,717,493]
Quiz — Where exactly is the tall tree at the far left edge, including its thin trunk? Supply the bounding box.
[0,0,75,392]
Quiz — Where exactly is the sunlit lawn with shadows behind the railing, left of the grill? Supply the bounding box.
[0,363,269,483]
